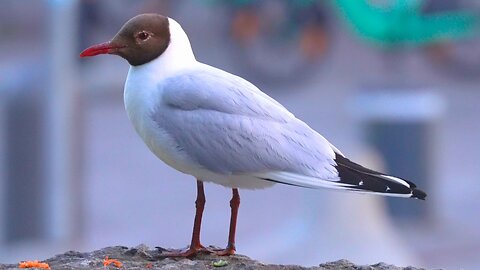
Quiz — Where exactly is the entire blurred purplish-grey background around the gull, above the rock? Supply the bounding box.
[0,0,480,269]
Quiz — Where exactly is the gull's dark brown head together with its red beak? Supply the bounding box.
[80,14,170,66]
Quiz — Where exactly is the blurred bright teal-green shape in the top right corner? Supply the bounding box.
[333,0,479,46]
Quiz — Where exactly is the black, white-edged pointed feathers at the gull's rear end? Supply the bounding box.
[335,153,427,200]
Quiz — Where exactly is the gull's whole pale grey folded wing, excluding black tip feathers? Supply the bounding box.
[152,68,338,184]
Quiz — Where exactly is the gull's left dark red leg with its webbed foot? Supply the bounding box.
[162,180,206,257]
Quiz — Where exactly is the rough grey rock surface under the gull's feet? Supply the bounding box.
[0,245,421,270]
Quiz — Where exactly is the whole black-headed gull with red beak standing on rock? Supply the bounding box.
[80,14,426,257]
